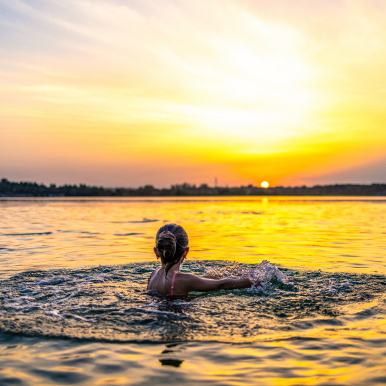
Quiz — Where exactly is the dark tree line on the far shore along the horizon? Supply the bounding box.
[0,178,386,197]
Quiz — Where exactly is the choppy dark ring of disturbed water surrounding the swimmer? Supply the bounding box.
[0,261,386,342]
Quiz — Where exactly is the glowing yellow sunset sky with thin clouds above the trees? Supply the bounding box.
[0,0,386,188]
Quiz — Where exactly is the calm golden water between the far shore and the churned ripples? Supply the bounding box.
[0,197,386,272]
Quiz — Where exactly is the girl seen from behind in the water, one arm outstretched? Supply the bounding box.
[147,224,260,296]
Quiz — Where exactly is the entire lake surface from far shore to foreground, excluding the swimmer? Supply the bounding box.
[0,197,386,386]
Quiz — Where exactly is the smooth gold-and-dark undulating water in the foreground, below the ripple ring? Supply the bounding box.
[0,333,385,386]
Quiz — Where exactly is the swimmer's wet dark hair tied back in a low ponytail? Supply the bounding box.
[155,224,189,277]
